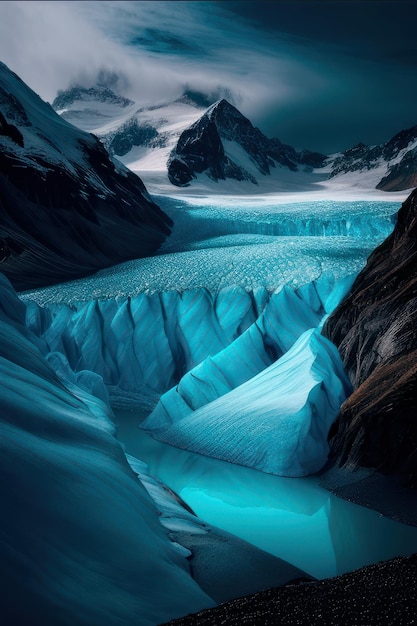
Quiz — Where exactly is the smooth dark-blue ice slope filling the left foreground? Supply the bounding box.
[0,277,213,626]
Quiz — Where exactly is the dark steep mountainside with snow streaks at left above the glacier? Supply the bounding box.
[0,64,171,290]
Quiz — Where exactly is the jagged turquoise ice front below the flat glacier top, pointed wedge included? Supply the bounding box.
[20,275,353,476]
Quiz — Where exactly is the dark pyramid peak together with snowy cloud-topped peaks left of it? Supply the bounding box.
[52,86,326,193]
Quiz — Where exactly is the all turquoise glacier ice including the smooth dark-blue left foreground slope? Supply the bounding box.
[4,194,406,626]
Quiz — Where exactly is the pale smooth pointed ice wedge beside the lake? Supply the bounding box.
[143,329,351,477]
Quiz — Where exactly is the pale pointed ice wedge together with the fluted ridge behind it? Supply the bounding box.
[142,279,351,476]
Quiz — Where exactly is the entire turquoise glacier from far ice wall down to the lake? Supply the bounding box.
[17,199,396,476]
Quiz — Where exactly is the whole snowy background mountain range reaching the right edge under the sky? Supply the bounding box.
[52,85,417,191]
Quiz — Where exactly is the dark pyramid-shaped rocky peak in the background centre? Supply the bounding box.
[168,99,326,186]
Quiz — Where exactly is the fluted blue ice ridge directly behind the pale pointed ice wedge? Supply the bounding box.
[146,276,353,430]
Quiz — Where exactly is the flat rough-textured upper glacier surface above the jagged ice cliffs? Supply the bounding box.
[21,196,400,306]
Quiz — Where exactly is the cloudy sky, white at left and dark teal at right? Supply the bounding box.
[0,0,417,154]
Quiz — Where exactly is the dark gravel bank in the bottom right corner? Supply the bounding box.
[162,554,417,626]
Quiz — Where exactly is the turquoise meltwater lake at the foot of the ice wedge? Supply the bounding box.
[115,410,417,579]
